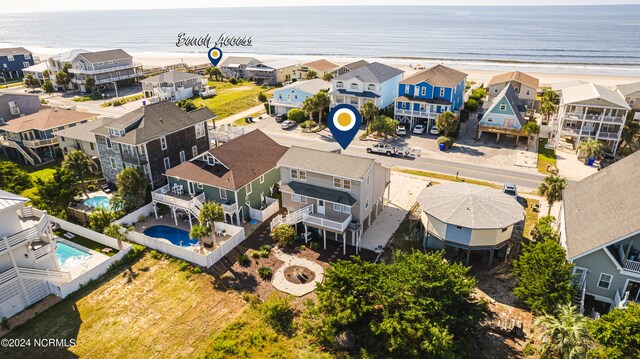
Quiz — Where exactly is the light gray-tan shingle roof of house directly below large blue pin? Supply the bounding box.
[278,146,375,181]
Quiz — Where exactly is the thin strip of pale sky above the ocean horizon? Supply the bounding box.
[0,0,640,13]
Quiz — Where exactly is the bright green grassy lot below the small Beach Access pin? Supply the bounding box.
[193,81,272,119]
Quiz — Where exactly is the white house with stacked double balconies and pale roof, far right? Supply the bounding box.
[555,83,631,155]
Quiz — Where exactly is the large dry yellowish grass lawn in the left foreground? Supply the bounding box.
[0,253,326,359]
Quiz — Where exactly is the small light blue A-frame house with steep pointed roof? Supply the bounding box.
[478,84,527,143]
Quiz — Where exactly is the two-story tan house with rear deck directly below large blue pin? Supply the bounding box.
[271,146,391,254]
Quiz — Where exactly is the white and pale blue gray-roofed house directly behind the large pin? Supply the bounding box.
[329,62,404,109]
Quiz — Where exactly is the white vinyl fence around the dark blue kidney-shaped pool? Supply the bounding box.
[125,222,245,268]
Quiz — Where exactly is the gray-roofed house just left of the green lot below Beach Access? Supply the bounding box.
[140,71,207,102]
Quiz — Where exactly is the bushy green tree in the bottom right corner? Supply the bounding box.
[589,302,640,359]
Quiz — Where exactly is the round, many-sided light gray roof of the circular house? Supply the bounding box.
[418,182,524,229]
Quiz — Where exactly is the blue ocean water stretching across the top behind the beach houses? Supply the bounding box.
[0,5,640,72]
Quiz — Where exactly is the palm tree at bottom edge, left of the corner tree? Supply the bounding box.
[533,304,593,359]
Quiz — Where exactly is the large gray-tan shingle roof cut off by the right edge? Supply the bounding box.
[562,152,640,258]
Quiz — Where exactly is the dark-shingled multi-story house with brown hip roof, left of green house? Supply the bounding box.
[91,101,216,188]
